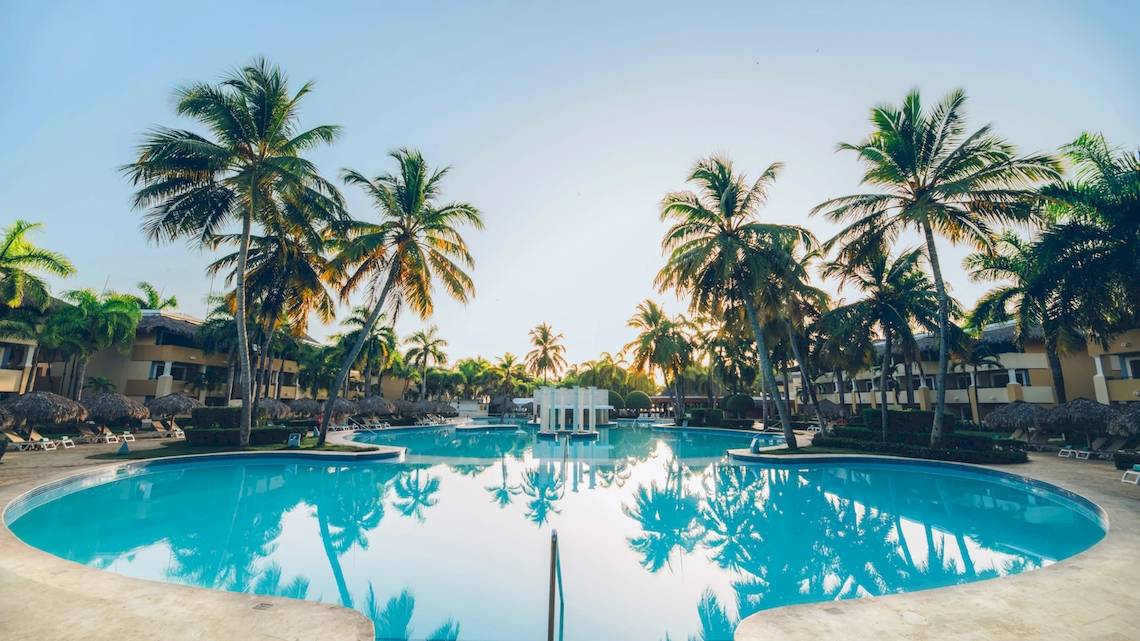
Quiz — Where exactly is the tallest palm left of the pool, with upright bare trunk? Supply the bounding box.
[123,58,343,446]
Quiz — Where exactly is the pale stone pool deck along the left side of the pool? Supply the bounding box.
[0,439,373,641]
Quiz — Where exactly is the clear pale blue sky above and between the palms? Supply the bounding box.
[0,0,1140,362]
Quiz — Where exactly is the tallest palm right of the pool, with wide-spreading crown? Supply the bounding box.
[812,90,1058,444]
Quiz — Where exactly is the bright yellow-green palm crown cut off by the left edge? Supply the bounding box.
[0,220,75,309]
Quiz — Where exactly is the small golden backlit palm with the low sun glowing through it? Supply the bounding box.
[622,300,692,424]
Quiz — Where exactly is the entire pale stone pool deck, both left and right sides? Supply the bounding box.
[0,431,1140,641]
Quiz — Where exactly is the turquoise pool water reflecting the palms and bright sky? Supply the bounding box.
[7,428,1105,641]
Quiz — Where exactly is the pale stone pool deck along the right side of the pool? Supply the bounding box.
[735,454,1140,641]
